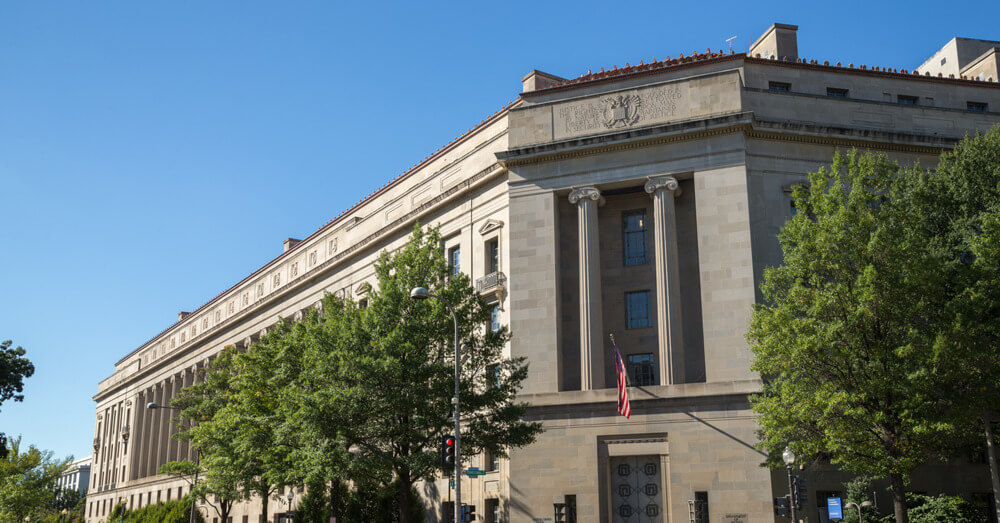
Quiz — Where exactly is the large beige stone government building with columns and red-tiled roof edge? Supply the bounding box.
[86,24,1000,523]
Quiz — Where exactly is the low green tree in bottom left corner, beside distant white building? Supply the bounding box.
[0,437,70,521]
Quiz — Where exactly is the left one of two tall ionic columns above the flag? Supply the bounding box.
[569,186,604,390]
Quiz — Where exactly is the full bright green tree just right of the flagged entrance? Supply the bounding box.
[747,152,963,523]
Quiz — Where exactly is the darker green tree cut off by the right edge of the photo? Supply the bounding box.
[917,126,1000,520]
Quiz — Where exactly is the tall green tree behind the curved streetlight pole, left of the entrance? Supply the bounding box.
[284,226,541,523]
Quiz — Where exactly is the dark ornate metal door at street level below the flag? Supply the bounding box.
[610,456,664,523]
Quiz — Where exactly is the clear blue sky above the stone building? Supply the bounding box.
[0,0,1000,457]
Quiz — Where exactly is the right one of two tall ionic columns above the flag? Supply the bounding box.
[646,176,684,385]
